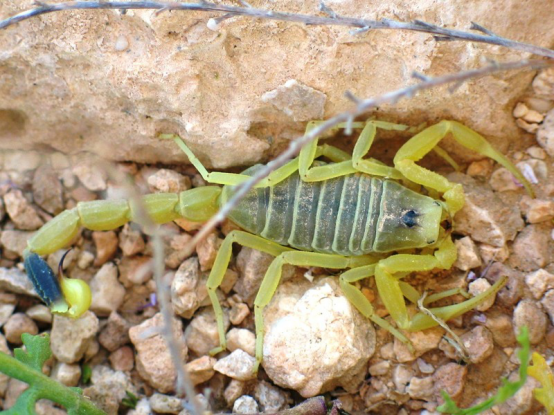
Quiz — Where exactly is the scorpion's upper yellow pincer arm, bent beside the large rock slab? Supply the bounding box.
[394,121,533,215]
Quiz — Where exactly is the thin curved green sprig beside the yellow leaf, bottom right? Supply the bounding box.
[437,327,531,415]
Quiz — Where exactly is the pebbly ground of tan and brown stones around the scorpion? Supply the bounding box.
[0,65,554,415]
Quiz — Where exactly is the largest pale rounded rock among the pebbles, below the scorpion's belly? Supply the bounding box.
[262,278,375,397]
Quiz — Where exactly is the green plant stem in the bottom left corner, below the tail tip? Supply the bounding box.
[0,352,106,415]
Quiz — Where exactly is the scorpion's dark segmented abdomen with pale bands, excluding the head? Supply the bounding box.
[222,165,383,256]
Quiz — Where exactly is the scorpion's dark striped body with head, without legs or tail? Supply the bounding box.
[221,165,443,256]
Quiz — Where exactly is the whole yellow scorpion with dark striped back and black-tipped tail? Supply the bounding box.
[24,120,533,371]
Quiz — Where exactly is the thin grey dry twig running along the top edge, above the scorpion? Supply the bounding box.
[0,1,554,58]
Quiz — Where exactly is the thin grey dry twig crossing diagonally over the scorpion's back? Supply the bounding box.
[185,60,554,252]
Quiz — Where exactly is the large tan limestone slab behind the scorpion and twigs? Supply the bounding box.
[0,0,554,168]
